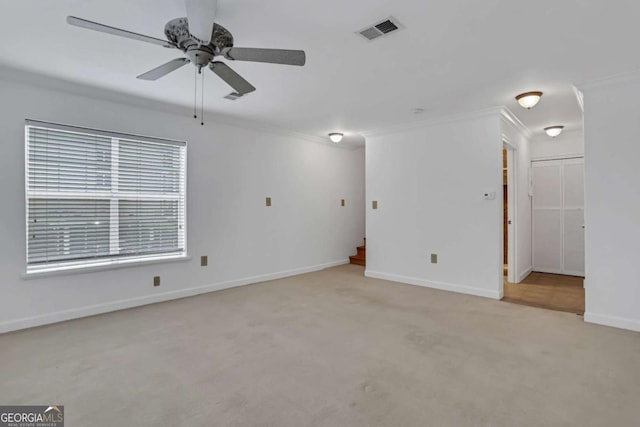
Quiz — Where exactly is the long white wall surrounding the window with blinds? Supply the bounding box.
[0,72,364,332]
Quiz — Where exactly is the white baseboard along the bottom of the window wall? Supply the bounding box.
[0,259,349,334]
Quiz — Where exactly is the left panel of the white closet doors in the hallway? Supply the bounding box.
[532,160,563,274]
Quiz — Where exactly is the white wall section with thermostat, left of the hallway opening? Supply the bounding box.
[366,110,503,298]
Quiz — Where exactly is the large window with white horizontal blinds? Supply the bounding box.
[26,120,186,273]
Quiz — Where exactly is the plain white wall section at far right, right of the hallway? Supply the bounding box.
[581,74,640,331]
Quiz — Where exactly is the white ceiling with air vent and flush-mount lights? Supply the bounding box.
[0,0,640,141]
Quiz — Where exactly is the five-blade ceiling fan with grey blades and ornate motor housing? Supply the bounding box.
[67,0,306,104]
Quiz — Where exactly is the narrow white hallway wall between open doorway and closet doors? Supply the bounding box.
[501,113,533,283]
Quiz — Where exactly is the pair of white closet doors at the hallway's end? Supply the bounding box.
[532,159,584,276]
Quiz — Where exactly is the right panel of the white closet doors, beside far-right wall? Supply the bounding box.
[563,159,584,276]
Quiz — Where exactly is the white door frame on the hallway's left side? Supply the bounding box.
[500,136,518,286]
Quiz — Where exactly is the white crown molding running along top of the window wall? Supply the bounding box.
[0,64,362,151]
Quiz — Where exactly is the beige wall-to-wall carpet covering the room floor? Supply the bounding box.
[0,265,640,427]
